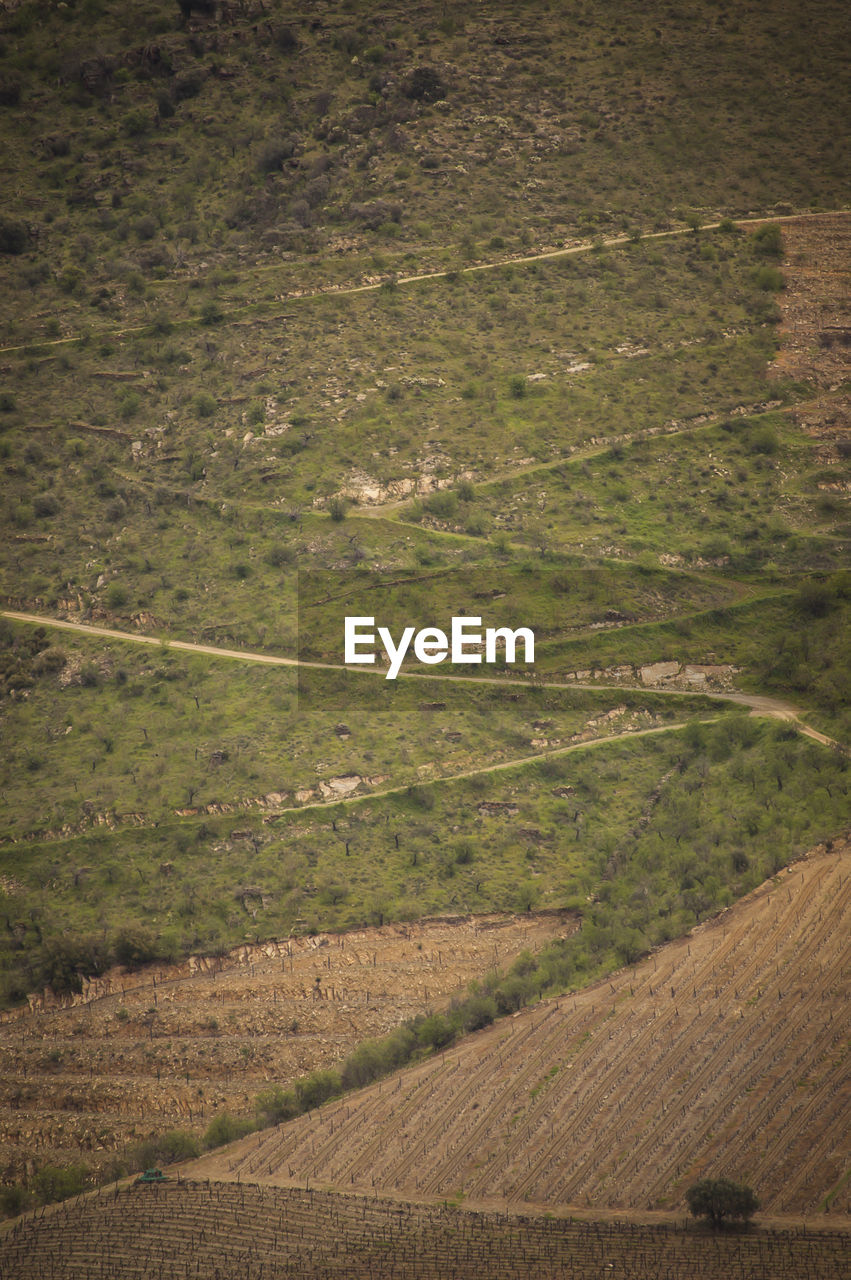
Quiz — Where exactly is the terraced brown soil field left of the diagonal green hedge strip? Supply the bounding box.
[0,911,576,1176]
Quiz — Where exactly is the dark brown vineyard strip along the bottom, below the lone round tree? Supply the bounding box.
[0,1181,851,1280]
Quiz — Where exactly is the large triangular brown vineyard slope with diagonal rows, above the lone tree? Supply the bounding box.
[188,838,851,1221]
